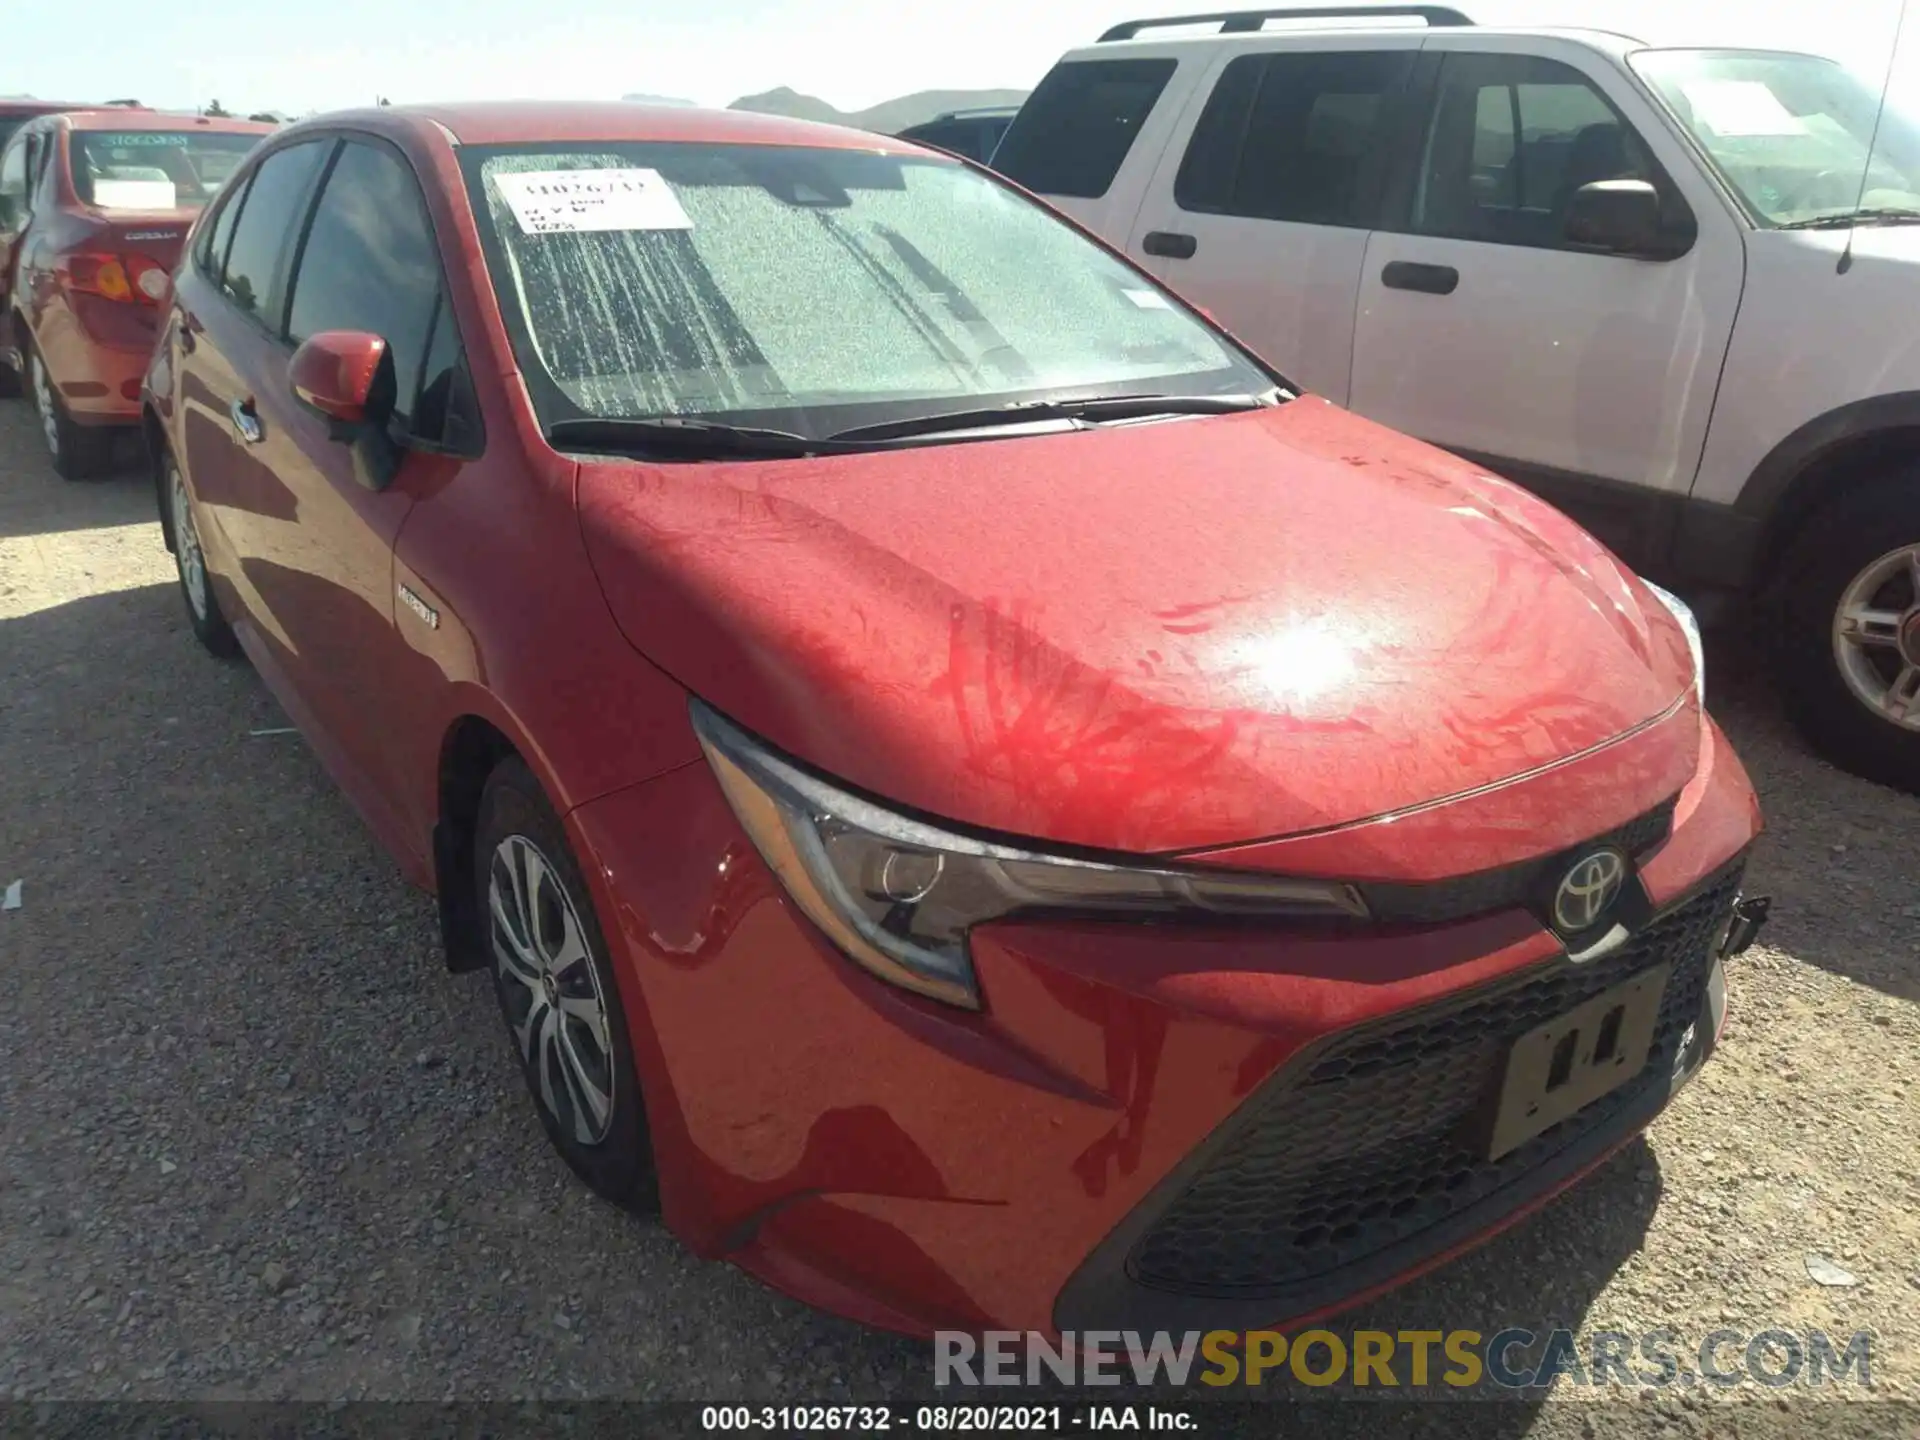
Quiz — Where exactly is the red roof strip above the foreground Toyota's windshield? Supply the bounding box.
[322,100,908,152]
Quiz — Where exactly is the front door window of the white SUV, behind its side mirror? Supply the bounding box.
[1413,56,1667,246]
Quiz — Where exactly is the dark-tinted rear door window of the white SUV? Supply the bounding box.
[1173,50,1413,228]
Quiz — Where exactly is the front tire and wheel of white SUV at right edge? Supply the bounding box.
[1778,480,1920,793]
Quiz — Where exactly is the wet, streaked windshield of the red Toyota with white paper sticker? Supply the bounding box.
[463,142,1275,445]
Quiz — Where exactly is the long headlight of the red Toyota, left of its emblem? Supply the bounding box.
[693,701,1367,1010]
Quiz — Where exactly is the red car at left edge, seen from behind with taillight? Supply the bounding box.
[0,109,275,480]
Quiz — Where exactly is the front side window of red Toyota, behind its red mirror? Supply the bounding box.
[286,140,440,420]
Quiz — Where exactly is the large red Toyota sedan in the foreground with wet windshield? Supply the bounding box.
[146,104,1761,1332]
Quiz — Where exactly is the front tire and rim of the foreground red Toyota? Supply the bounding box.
[474,756,657,1212]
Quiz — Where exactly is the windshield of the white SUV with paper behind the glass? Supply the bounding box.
[1634,50,1920,225]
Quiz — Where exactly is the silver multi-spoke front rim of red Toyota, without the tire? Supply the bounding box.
[488,835,614,1144]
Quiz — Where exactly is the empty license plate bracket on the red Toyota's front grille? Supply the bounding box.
[1486,964,1672,1160]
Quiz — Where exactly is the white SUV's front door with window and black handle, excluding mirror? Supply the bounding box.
[1352,36,1743,564]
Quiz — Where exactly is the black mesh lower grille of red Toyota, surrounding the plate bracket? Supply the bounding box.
[1127,872,1740,1296]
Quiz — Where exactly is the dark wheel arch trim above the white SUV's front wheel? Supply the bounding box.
[1734,390,1920,589]
